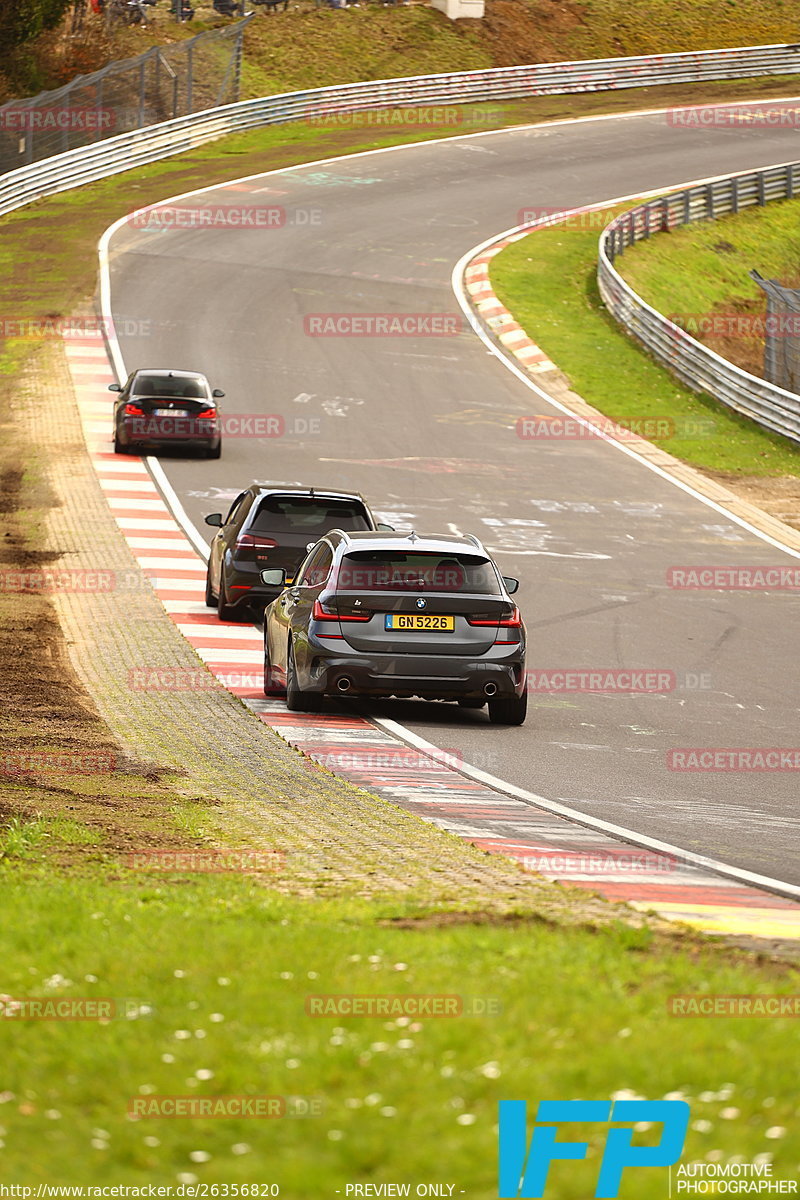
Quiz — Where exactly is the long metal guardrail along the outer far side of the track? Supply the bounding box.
[0,43,800,216]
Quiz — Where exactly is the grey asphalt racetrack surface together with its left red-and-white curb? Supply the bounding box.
[67,100,800,937]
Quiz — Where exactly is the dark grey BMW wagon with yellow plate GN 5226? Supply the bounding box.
[261,529,528,725]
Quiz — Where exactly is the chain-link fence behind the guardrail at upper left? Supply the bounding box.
[0,16,252,174]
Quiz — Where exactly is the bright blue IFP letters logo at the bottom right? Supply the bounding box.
[498,1100,690,1200]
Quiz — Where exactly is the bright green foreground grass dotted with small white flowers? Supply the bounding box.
[0,856,796,1200]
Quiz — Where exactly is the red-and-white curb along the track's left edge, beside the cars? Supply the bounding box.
[65,331,800,938]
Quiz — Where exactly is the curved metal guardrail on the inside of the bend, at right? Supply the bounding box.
[597,162,800,442]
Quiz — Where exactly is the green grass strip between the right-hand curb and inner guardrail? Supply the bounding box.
[491,210,800,476]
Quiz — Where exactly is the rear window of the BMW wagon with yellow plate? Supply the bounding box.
[337,551,501,596]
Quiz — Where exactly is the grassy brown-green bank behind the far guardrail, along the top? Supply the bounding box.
[12,0,796,98]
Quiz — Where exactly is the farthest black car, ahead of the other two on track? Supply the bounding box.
[108,367,224,458]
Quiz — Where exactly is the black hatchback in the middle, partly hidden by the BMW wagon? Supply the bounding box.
[205,484,391,620]
